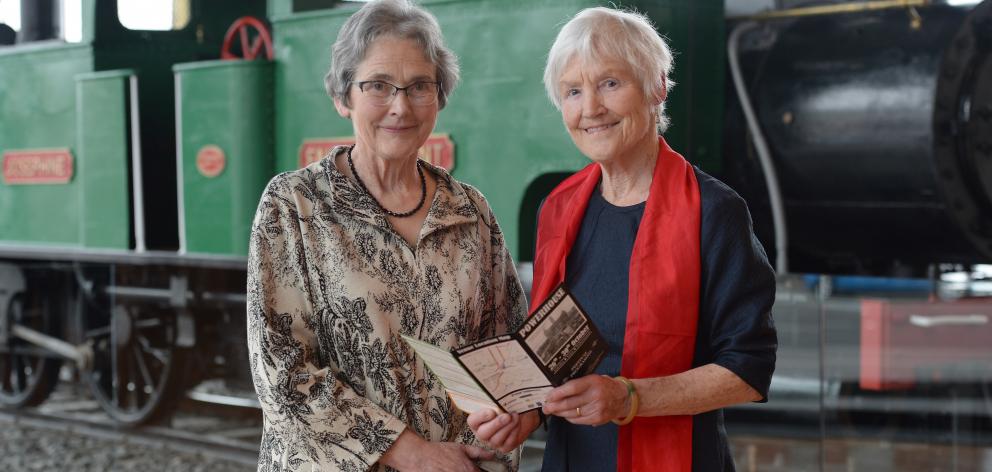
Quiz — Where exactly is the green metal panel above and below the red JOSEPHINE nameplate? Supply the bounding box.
[0,43,93,246]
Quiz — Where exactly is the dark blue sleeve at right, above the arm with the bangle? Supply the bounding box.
[695,171,778,402]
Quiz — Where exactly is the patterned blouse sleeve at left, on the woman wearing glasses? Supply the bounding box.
[247,176,406,471]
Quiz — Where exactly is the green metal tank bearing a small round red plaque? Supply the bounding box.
[174,61,274,255]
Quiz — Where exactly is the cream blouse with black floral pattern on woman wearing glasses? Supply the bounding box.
[248,147,526,471]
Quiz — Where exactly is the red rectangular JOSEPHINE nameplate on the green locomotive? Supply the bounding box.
[3,149,73,185]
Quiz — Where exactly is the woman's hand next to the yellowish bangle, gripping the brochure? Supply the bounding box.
[544,374,630,426]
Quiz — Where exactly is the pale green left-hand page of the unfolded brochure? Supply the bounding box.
[400,334,500,413]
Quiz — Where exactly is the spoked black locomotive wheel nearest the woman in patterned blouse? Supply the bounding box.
[83,306,186,426]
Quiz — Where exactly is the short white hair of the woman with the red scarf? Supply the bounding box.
[544,7,675,133]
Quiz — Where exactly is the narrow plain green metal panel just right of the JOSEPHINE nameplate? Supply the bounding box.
[76,70,134,249]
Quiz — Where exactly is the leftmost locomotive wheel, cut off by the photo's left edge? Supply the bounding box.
[0,294,62,408]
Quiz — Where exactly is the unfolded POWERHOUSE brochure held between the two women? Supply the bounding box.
[403,285,607,413]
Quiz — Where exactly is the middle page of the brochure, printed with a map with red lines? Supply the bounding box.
[457,335,553,413]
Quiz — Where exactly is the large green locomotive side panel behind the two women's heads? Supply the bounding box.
[270,0,724,262]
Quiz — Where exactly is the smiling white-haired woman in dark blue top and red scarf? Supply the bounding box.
[469,8,777,472]
